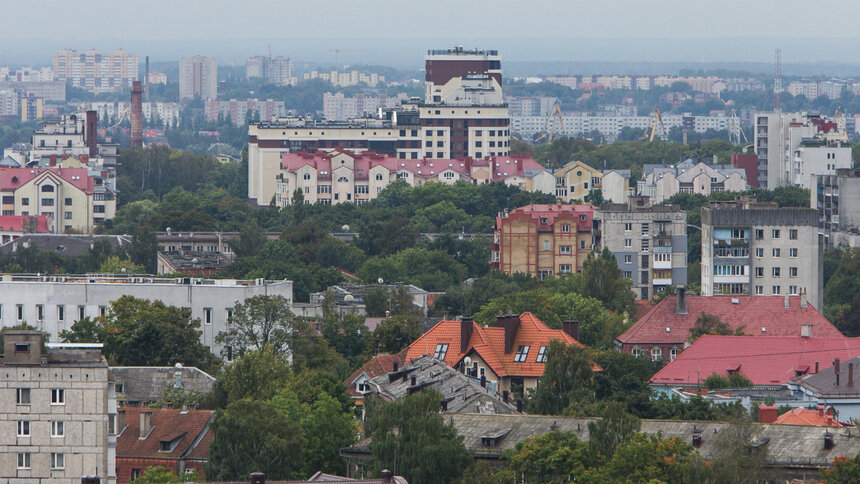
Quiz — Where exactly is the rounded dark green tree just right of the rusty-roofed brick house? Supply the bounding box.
[204,399,304,481]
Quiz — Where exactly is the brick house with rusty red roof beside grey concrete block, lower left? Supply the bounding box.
[116,407,215,484]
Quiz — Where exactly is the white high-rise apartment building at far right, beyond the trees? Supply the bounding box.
[755,113,853,190]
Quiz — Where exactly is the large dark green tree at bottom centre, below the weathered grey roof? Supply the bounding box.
[366,391,472,484]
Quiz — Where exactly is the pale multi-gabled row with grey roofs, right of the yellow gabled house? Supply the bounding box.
[637,158,749,203]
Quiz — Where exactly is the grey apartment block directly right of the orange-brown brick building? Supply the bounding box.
[594,197,687,299]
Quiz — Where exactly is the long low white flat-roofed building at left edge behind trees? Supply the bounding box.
[0,274,293,356]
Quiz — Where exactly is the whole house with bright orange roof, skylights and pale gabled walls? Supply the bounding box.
[406,312,600,394]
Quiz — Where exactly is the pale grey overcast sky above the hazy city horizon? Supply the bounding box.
[5,0,860,62]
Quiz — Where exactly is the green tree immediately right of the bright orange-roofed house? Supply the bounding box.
[526,340,594,415]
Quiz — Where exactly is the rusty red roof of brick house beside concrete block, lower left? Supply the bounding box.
[116,407,215,459]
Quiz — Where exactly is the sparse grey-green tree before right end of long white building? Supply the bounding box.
[215,295,303,353]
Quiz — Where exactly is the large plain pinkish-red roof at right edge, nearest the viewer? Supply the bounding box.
[651,335,860,386]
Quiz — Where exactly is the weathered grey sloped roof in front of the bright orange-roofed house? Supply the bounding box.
[364,355,517,413]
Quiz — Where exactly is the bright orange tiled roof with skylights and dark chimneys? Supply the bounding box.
[406,312,600,377]
